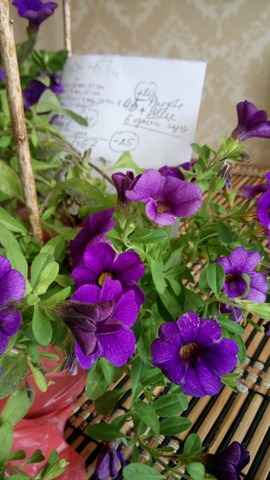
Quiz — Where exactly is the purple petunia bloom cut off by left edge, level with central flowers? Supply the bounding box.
[0,257,25,354]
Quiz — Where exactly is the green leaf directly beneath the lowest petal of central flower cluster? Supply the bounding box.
[85,358,122,400]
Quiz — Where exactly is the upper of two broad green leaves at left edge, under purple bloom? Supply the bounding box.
[0,353,27,398]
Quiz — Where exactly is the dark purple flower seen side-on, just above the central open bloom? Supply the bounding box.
[70,208,115,268]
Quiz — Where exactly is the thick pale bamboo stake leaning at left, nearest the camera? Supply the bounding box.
[0,0,43,244]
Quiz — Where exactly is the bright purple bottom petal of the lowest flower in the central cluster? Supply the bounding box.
[98,328,136,367]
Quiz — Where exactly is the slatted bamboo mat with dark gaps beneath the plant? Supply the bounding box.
[65,166,270,480]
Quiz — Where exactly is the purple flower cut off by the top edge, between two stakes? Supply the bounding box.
[13,0,58,33]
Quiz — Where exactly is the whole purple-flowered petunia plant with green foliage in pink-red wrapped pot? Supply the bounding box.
[0,0,270,480]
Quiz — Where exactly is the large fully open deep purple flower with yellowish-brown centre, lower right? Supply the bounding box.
[151,312,238,397]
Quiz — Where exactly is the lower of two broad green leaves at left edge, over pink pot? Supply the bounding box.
[1,387,32,426]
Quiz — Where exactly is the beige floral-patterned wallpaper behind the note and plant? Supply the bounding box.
[11,0,270,166]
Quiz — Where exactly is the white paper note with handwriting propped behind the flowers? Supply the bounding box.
[58,55,206,168]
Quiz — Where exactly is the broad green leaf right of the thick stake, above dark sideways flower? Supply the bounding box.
[59,178,104,208]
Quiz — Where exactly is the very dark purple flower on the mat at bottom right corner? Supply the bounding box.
[202,442,250,480]
